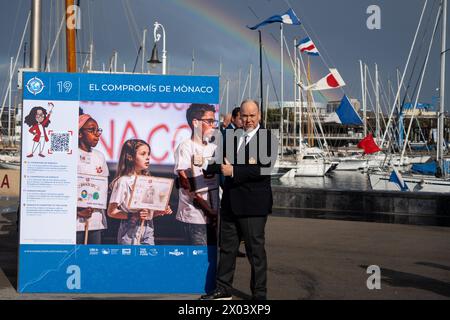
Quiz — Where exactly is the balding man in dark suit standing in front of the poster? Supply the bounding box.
[201,100,277,300]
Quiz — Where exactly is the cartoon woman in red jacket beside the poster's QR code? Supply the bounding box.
[24,102,54,158]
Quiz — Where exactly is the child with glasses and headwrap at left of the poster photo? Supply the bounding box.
[77,109,109,244]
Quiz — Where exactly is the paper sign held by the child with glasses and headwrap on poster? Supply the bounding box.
[77,174,108,209]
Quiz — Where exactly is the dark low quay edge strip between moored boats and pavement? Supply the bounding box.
[273,186,450,227]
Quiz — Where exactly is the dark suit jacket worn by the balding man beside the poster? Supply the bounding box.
[206,126,277,216]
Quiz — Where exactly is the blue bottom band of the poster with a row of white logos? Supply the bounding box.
[18,245,217,294]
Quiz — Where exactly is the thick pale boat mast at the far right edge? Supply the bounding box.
[436,0,448,176]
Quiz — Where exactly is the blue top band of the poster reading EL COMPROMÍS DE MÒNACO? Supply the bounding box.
[23,72,219,104]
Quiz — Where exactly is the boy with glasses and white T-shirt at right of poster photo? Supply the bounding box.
[174,104,219,245]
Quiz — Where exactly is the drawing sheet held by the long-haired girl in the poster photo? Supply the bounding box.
[128,176,173,211]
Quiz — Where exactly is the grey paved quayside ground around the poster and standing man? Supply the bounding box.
[0,213,450,300]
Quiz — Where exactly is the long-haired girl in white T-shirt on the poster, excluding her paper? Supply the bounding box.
[108,139,172,245]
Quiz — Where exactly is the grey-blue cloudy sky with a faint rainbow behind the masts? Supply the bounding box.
[0,0,450,114]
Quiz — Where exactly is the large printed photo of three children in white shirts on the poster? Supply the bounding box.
[77,102,219,245]
